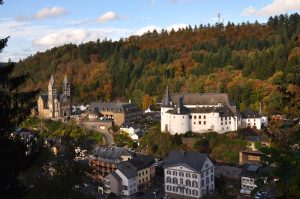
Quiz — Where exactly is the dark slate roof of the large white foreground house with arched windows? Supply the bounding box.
[165,151,208,172]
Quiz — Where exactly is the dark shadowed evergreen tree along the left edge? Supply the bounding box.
[0,0,36,198]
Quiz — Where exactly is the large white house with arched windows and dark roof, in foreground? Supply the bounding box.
[164,151,215,198]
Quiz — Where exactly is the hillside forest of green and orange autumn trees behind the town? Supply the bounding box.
[15,13,300,116]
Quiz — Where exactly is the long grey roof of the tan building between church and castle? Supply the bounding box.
[89,102,141,112]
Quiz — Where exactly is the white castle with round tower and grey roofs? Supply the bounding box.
[161,88,268,134]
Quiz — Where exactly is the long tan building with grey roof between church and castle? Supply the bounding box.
[89,102,142,126]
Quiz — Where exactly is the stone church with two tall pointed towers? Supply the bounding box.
[37,75,72,121]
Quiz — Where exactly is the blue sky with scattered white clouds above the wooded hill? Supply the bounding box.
[0,0,300,61]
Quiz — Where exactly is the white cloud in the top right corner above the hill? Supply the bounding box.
[241,0,300,16]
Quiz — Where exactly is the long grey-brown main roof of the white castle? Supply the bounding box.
[162,93,230,106]
